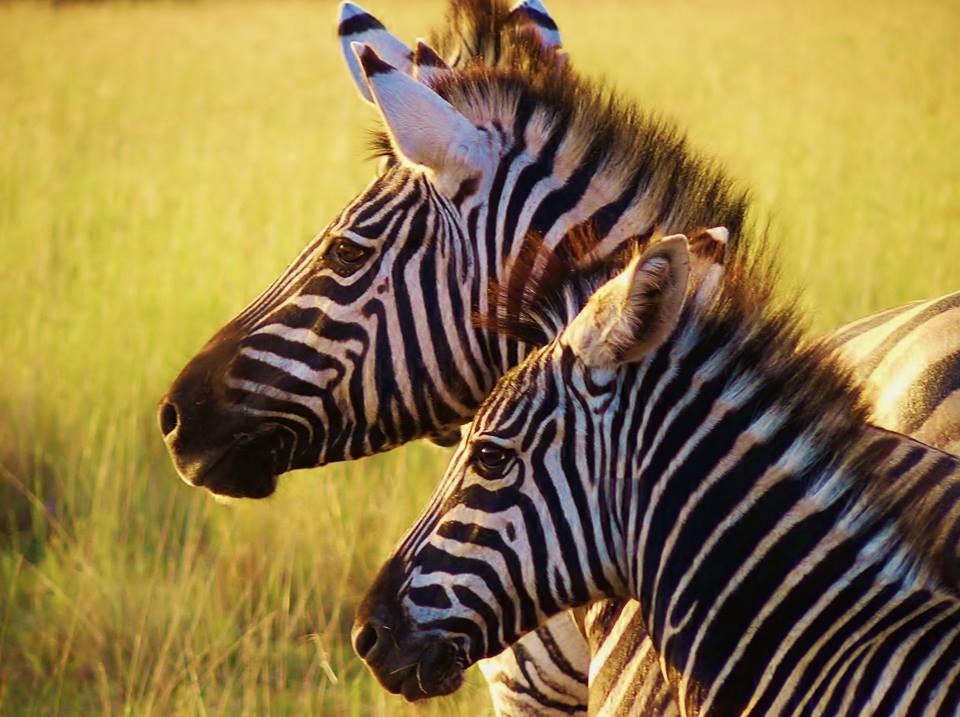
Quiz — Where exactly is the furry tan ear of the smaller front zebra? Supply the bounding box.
[563,234,690,368]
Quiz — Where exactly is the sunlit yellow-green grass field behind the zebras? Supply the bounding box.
[0,0,960,716]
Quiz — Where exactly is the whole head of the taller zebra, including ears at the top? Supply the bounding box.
[159,0,565,498]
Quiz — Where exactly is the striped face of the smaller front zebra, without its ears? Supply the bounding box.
[354,344,576,700]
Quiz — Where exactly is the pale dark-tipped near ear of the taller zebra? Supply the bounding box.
[353,43,486,172]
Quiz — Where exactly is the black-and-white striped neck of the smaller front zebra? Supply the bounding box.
[609,310,955,704]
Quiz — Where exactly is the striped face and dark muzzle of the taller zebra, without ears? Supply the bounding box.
[160,159,498,497]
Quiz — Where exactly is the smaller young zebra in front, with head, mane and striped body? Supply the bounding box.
[354,235,960,715]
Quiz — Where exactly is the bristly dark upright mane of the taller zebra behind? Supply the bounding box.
[371,0,749,258]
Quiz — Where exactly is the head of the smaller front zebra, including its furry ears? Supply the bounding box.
[353,228,727,699]
